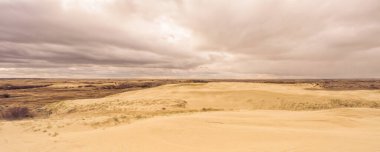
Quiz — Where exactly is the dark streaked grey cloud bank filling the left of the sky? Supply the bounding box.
[0,1,202,68]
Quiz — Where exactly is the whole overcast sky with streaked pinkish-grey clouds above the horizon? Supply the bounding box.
[0,0,380,79]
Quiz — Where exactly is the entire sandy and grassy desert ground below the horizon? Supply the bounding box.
[0,79,380,152]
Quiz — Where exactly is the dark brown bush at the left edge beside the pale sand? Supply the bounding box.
[0,107,33,120]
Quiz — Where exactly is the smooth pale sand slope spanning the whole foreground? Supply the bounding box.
[0,109,380,152]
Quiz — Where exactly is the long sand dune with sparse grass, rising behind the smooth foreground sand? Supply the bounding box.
[47,82,380,115]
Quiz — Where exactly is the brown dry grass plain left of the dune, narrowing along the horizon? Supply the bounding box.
[0,79,194,117]
